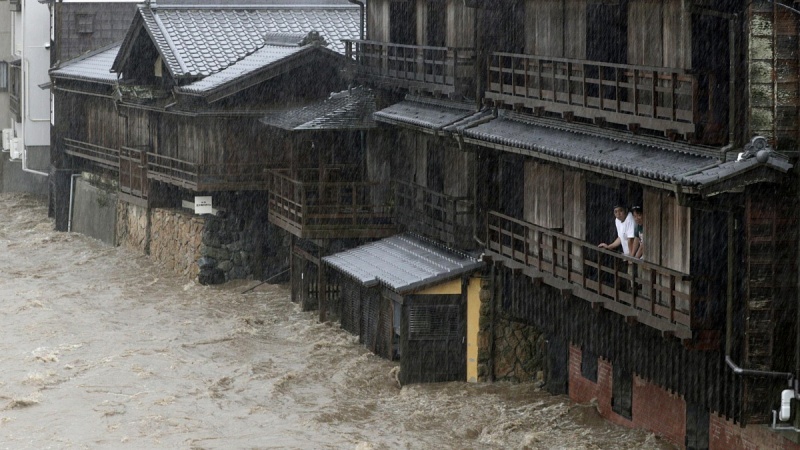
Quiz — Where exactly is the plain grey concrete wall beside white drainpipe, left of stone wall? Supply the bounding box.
[71,179,117,245]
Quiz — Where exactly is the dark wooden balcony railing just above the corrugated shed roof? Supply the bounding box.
[395,181,475,249]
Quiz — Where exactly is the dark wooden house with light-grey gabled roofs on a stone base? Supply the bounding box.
[51,4,359,281]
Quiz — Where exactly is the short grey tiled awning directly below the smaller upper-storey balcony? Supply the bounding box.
[374,98,475,131]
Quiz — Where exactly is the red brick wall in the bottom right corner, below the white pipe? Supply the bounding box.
[708,414,800,450]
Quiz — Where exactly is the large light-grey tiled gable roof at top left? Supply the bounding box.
[132,5,359,78]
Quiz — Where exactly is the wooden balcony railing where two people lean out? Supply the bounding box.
[486,212,700,339]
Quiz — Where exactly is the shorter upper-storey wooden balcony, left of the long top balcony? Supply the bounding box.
[344,40,475,96]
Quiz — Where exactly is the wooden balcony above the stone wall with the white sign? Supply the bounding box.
[147,153,276,191]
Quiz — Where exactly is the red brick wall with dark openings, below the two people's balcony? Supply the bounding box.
[569,346,686,448]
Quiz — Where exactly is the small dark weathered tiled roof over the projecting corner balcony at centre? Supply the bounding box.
[261,88,375,130]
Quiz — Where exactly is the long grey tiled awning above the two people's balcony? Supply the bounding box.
[461,111,718,182]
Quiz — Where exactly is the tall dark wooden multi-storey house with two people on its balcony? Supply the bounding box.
[348,0,800,448]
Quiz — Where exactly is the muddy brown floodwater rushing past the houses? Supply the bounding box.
[0,194,672,450]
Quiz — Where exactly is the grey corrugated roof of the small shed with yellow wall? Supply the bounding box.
[322,234,483,294]
